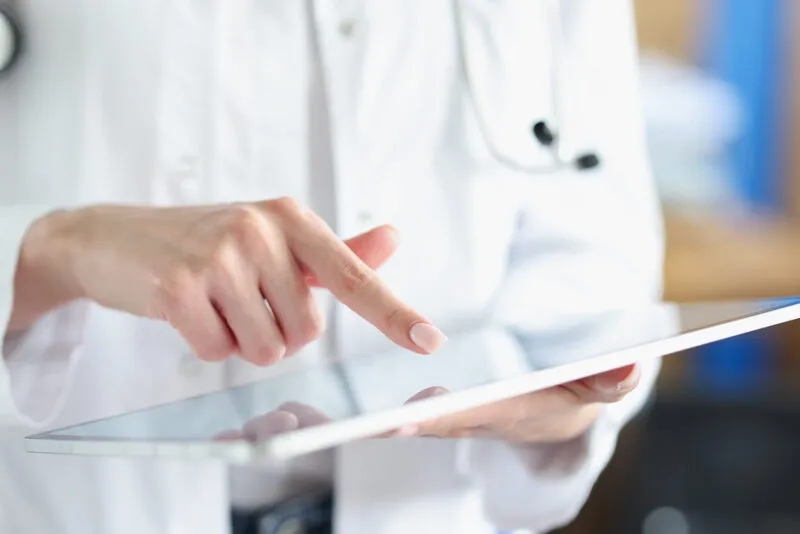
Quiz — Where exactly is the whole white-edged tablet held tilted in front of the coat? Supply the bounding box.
[25,300,800,463]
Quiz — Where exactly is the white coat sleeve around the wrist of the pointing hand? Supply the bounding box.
[0,206,87,428]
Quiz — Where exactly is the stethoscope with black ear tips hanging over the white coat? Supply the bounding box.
[0,0,600,174]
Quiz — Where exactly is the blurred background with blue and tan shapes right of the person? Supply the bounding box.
[560,0,800,534]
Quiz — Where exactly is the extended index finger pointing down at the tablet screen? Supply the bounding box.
[287,214,446,354]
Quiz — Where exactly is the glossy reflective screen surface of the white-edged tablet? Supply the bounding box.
[28,301,800,460]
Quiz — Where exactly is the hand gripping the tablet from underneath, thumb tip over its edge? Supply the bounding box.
[409,365,640,443]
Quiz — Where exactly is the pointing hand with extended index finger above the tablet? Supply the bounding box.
[12,198,444,365]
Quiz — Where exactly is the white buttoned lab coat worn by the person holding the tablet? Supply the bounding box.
[0,0,662,534]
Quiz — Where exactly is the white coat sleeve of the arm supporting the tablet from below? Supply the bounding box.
[464,0,664,533]
